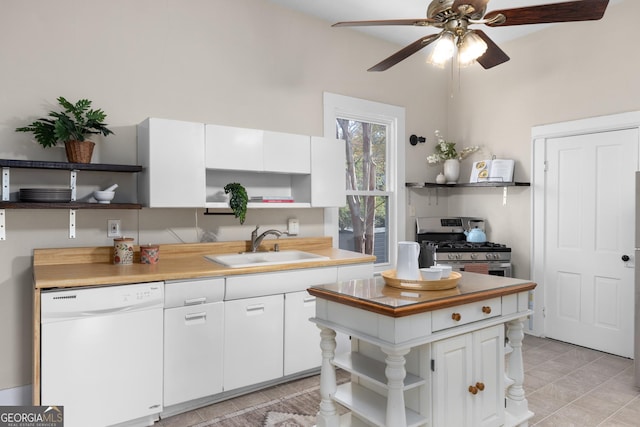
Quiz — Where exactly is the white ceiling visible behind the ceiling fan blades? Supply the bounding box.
[270,0,624,46]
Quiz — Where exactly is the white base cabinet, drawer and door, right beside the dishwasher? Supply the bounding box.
[164,279,224,408]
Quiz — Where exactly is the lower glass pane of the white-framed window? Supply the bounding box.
[339,196,389,264]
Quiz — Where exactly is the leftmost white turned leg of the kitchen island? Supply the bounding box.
[316,326,340,427]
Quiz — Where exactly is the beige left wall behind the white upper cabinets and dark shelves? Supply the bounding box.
[0,0,446,394]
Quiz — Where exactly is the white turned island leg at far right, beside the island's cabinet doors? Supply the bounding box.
[506,319,533,427]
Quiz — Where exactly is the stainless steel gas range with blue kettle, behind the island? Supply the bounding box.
[416,217,511,277]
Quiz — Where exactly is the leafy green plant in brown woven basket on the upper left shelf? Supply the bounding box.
[16,96,113,163]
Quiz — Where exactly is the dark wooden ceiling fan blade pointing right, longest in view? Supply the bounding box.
[485,0,609,27]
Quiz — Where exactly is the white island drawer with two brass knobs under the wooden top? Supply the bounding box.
[432,297,502,332]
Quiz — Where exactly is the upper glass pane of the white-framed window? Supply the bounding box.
[336,118,387,191]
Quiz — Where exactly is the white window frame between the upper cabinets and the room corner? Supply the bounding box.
[323,92,405,273]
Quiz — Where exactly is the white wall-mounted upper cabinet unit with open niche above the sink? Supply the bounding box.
[138,118,345,209]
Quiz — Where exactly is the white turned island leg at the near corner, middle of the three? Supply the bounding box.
[382,347,409,427]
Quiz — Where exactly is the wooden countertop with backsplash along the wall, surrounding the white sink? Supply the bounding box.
[33,237,375,289]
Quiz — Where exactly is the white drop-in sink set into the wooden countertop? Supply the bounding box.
[205,250,329,268]
